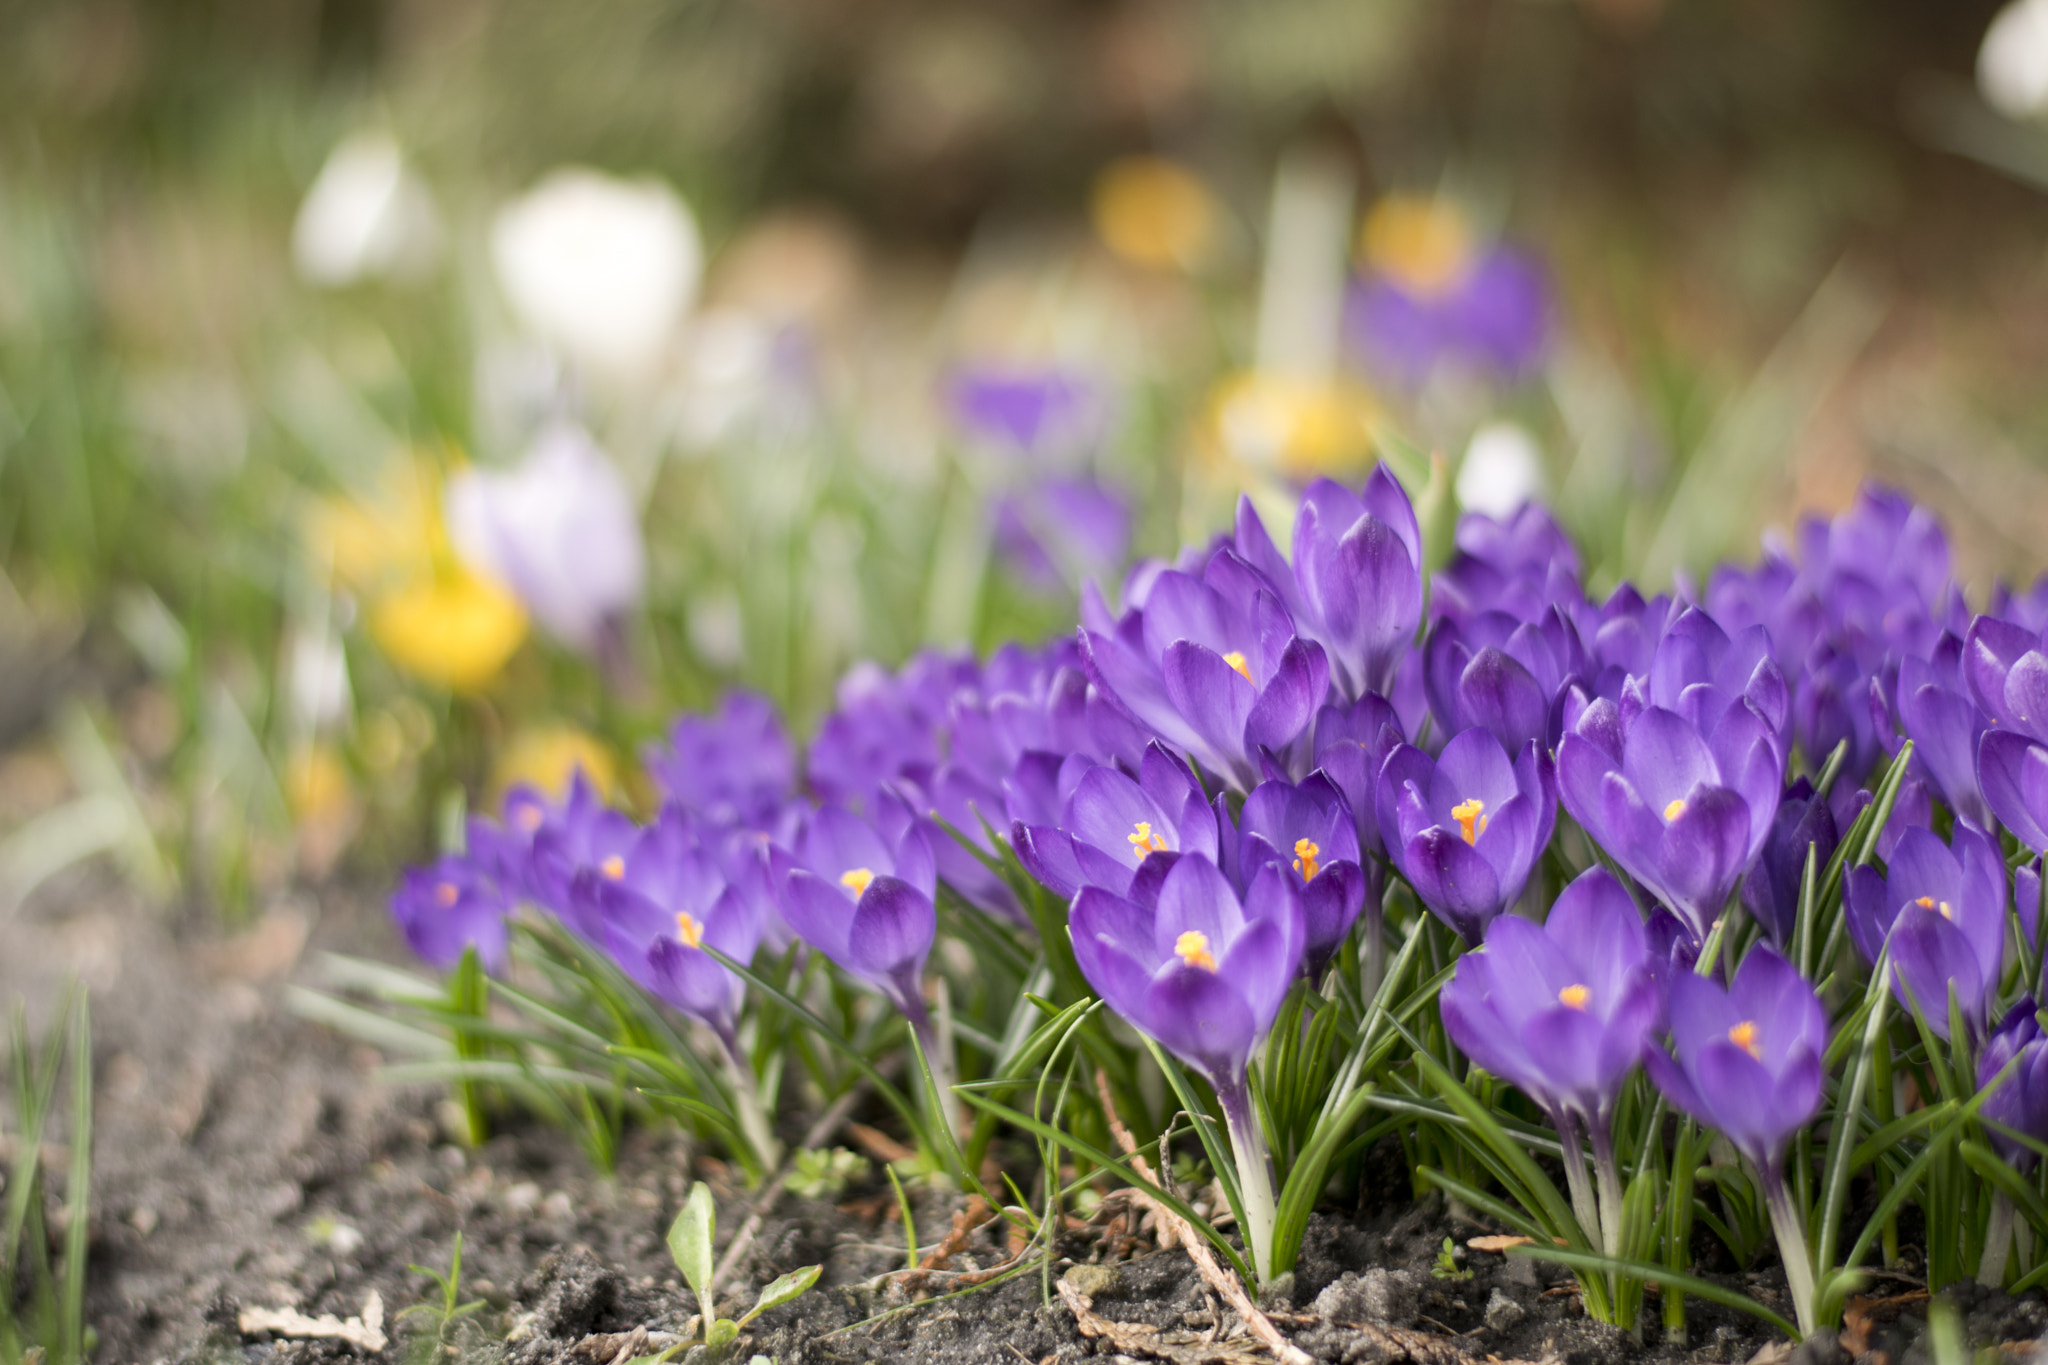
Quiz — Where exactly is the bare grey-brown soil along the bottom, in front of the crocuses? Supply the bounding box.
[12,874,2048,1365]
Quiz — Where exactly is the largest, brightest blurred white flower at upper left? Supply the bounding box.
[492,170,705,379]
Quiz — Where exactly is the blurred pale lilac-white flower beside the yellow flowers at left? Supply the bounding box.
[444,424,647,653]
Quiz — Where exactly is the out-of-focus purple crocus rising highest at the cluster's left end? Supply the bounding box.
[641,692,797,829]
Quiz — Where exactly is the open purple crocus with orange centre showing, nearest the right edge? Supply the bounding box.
[1845,823,2005,1038]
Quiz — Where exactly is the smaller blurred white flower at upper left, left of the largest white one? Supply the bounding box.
[291,133,440,289]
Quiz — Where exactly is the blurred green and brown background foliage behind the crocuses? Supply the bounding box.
[0,0,2048,907]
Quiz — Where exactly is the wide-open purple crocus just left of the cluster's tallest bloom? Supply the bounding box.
[1081,551,1329,792]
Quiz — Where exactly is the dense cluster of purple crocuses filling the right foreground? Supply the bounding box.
[395,472,2048,1320]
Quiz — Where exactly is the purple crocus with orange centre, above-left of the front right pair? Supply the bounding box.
[1374,729,1556,948]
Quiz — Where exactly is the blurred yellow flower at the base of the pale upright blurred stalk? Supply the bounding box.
[1208,370,1382,479]
